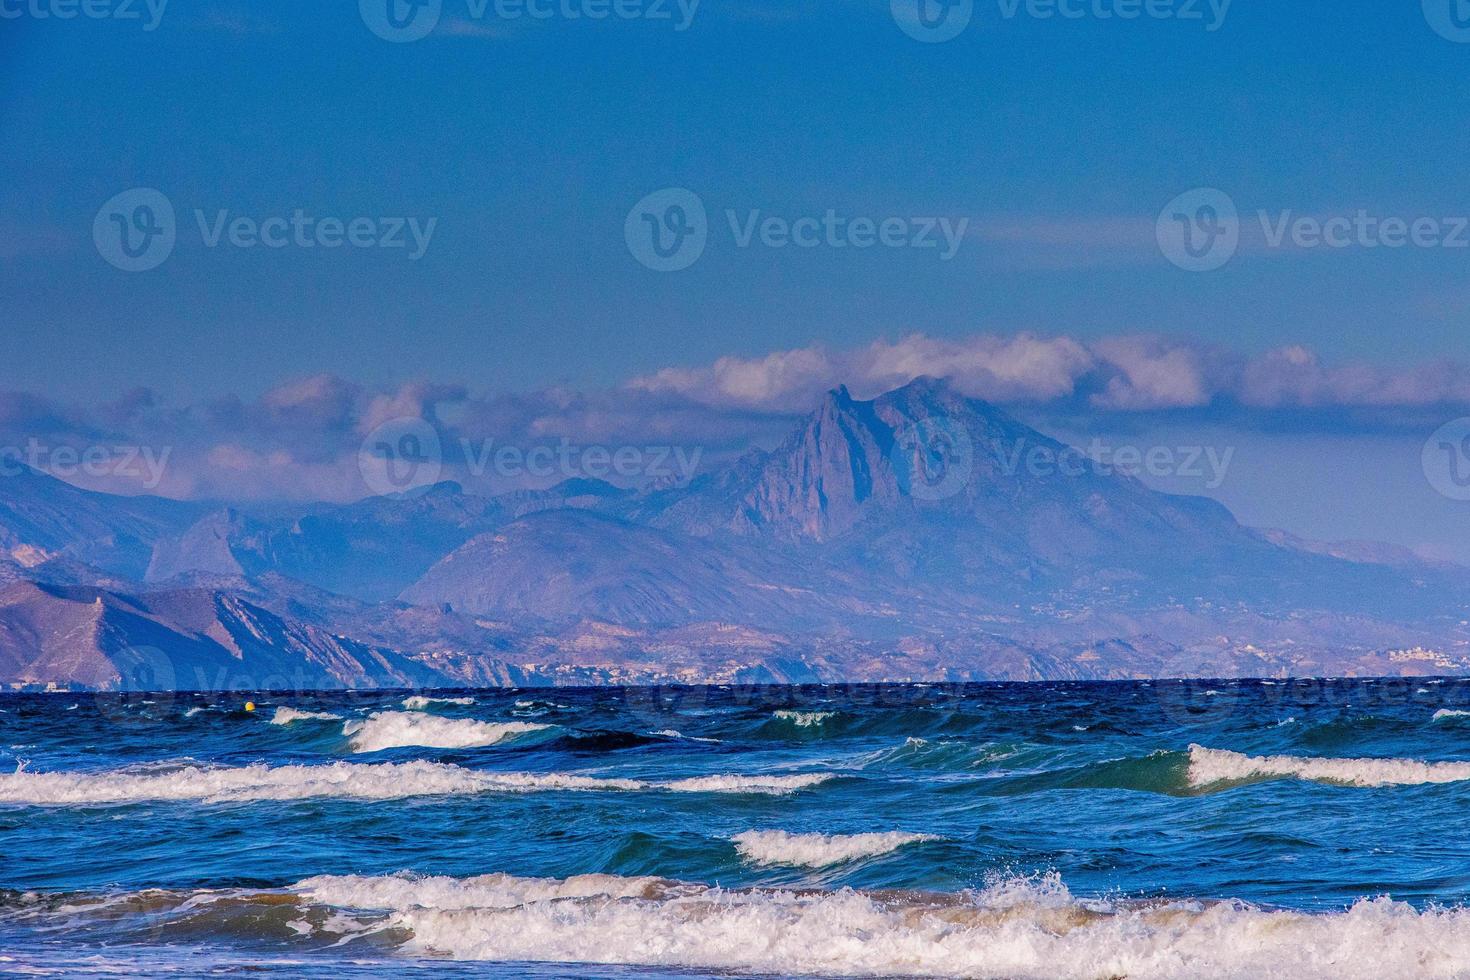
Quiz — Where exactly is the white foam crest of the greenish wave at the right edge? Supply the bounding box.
[1189,745,1470,788]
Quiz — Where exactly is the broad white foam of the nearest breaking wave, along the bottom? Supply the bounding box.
[293,874,1470,980]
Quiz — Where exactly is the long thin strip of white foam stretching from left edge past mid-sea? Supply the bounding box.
[0,760,828,807]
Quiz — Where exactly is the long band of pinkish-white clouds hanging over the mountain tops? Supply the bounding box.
[0,334,1470,501]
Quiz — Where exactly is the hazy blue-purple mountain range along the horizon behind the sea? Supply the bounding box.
[0,379,1470,689]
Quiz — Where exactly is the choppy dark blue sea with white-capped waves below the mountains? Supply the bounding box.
[0,680,1470,979]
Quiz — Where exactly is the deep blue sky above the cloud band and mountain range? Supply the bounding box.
[0,0,1470,557]
